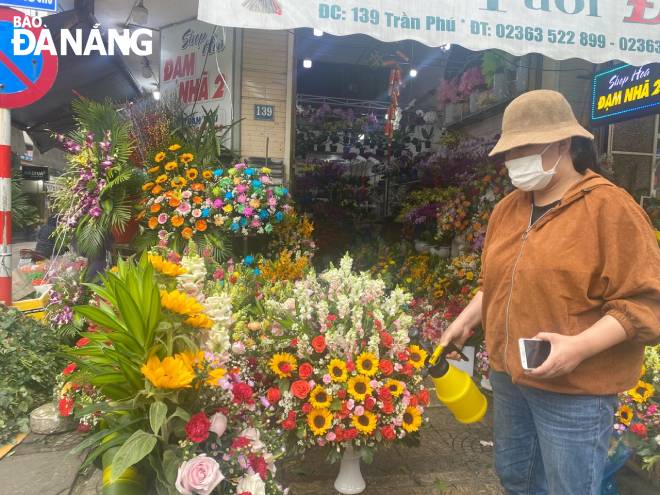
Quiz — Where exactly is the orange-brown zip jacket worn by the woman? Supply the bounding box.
[481,171,660,395]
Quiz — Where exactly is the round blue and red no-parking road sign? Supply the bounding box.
[0,7,57,108]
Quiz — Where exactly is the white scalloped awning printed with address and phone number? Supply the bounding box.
[198,0,660,65]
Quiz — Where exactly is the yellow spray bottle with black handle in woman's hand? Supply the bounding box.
[428,344,488,423]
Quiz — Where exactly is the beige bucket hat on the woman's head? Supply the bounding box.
[489,89,594,156]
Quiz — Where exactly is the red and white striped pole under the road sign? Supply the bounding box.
[0,108,11,306]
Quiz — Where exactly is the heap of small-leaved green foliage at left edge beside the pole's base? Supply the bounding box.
[0,306,64,444]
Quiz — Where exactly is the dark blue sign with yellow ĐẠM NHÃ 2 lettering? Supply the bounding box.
[591,64,660,125]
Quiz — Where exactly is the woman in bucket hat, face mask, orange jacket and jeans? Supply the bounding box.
[441,90,660,495]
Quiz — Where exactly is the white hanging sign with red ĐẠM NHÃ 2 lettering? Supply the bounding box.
[160,21,234,130]
